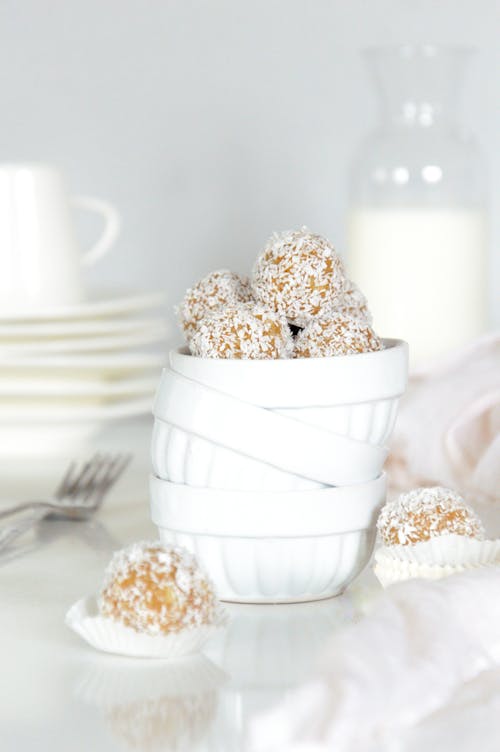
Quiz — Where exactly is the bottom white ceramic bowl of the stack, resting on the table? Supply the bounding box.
[151,475,386,603]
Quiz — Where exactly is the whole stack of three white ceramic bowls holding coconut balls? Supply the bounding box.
[151,340,408,603]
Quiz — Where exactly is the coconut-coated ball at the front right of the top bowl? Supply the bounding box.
[294,313,382,358]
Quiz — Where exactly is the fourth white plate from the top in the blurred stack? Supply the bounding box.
[0,352,166,379]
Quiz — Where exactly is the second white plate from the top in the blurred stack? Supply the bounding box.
[0,318,165,345]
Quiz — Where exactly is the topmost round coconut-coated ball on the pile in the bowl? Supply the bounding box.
[252,227,345,326]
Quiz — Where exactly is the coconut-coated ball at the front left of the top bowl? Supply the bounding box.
[189,303,293,360]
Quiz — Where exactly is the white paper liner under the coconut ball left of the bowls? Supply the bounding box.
[65,596,228,659]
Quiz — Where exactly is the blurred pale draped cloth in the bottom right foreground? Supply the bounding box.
[248,567,500,752]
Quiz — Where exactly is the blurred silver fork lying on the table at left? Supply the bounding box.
[0,454,132,551]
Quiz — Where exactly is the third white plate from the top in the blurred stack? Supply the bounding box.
[0,324,168,356]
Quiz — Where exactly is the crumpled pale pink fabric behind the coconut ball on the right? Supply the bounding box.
[387,332,500,503]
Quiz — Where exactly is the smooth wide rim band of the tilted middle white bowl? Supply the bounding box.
[152,369,387,488]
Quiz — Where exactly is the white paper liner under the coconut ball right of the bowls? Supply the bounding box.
[374,535,500,587]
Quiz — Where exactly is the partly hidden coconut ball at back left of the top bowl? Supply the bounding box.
[178,269,252,341]
